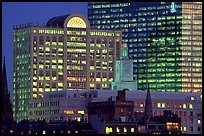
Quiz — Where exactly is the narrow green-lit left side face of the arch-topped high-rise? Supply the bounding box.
[13,28,31,120]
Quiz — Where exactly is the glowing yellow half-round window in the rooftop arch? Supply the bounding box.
[67,17,86,28]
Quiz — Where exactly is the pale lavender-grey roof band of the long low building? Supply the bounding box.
[44,90,201,101]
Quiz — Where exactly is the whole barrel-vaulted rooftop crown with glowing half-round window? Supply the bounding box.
[46,14,90,28]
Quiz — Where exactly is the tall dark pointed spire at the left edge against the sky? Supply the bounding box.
[1,57,14,132]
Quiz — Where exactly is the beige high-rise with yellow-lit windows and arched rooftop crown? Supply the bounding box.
[13,14,122,121]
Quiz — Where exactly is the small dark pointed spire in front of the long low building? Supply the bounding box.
[144,84,153,117]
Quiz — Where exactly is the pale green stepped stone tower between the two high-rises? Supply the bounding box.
[112,44,137,90]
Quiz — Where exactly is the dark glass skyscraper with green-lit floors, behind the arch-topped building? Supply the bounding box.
[88,2,202,92]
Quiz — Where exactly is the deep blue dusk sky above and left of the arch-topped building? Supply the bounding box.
[2,2,88,100]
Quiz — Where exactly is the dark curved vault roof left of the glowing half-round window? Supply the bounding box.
[46,14,70,27]
